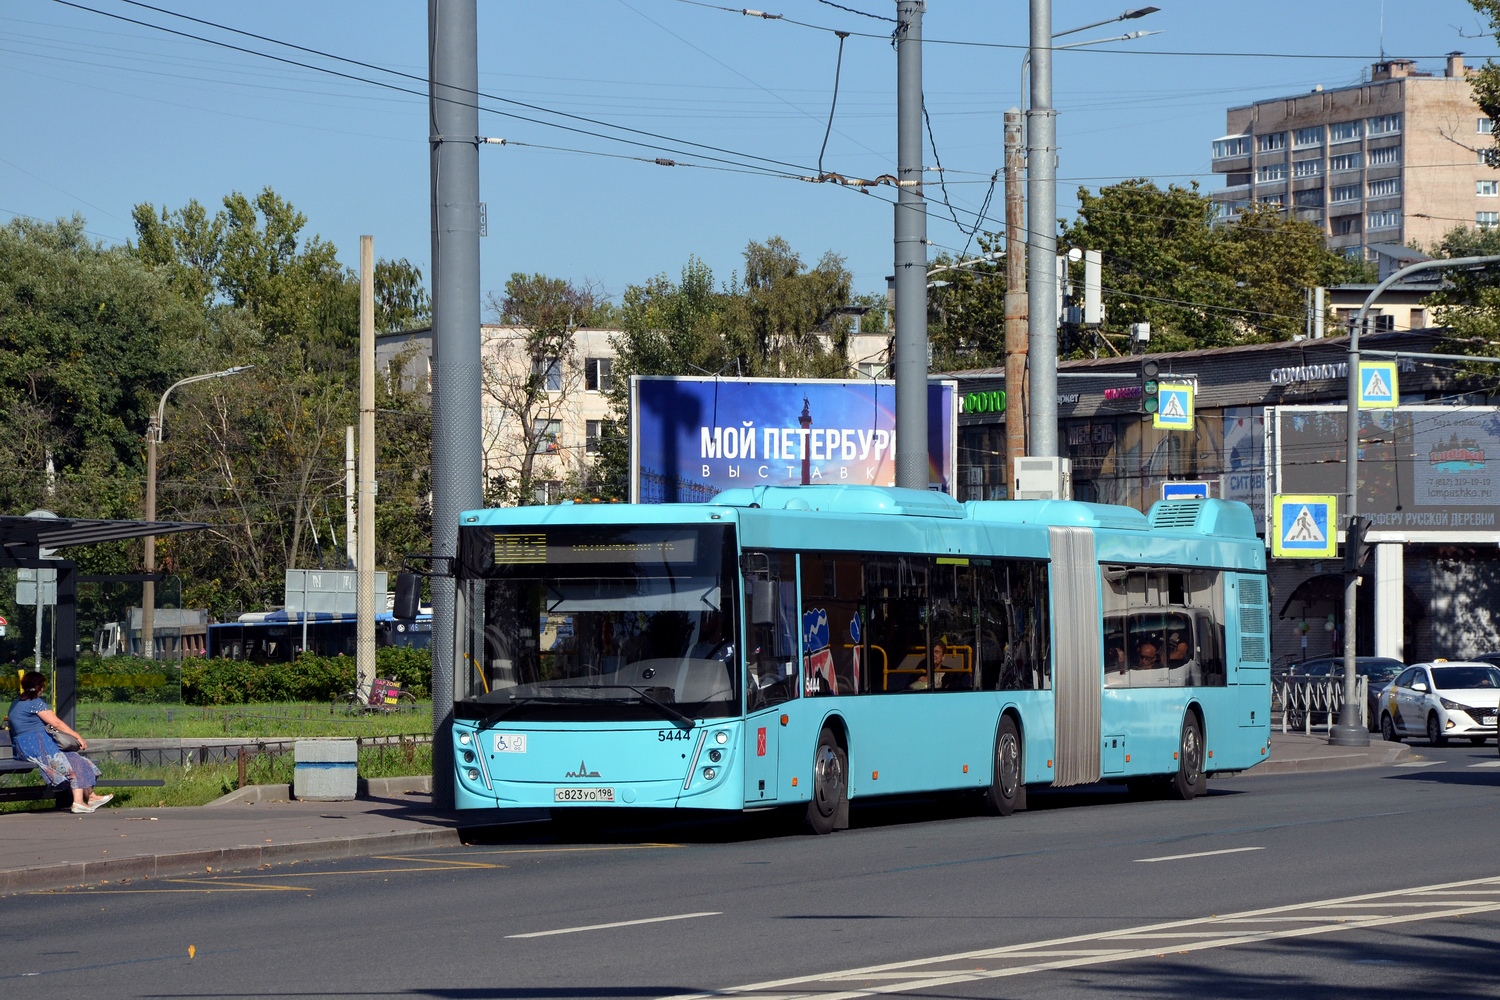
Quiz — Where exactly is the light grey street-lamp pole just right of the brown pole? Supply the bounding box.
[1026,0,1058,457]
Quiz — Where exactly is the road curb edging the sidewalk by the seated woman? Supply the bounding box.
[0,828,461,895]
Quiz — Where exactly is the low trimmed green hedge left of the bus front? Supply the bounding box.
[182,646,432,705]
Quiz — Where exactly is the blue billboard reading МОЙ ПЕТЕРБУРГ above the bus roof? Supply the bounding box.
[630,375,959,504]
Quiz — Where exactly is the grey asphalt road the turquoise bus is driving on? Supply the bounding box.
[0,744,1500,1000]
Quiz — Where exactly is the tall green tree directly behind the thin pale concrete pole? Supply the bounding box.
[132,189,431,615]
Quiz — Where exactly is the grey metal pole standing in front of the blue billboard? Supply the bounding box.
[896,0,929,490]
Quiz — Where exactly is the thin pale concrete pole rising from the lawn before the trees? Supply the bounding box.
[354,235,375,700]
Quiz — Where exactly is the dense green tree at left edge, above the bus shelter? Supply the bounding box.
[0,217,203,517]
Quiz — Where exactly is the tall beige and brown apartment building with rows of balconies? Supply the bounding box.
[1211,52,1500,258]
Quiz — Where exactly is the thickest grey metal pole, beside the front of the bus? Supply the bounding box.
[428,0,485,808]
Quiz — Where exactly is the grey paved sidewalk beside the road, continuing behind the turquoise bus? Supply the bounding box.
[0,733,1410,895]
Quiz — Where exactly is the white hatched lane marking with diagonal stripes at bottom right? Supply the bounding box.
[668,877,1500,1000]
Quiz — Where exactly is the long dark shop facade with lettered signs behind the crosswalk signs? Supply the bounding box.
[953,330,1500,663]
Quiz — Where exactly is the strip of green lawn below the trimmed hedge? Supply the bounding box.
[77,702,432,739]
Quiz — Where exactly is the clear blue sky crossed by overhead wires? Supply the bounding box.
[0,0,1497,307]
